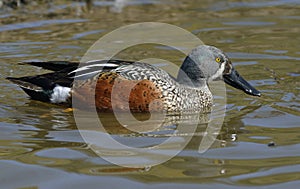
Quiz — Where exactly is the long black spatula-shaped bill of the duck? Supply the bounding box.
[223,68,261,96]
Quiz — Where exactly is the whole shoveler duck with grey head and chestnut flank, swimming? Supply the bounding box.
[7,45,260,112]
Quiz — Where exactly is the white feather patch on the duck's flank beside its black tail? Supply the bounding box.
[50,85,71,103]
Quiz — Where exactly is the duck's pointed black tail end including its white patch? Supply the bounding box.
[6,61,78,103]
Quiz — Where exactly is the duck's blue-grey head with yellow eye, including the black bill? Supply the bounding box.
[177,45,261,96]
